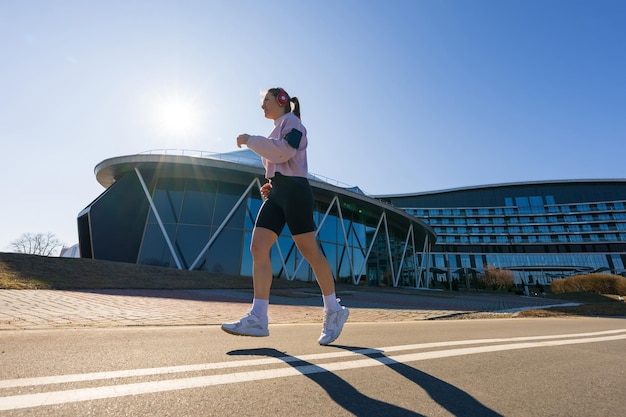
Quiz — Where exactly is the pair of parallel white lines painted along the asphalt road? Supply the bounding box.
[0,329,626,410]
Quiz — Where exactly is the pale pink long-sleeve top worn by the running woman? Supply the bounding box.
[247,113,308,179]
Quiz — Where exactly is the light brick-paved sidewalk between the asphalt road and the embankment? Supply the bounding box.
[0,286,562,330]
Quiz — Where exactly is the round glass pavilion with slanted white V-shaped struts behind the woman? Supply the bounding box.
[78,150,437,288]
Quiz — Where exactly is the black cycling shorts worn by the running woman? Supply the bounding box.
[255,172,315,236]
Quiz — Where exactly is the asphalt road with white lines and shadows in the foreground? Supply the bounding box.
[0,318,626,417]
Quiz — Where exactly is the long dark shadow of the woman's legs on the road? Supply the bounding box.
[228,345,502,417]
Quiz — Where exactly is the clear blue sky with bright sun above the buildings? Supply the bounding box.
[0,0,626,251]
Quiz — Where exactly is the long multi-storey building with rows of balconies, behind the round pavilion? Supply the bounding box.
[379,179,626,284]
